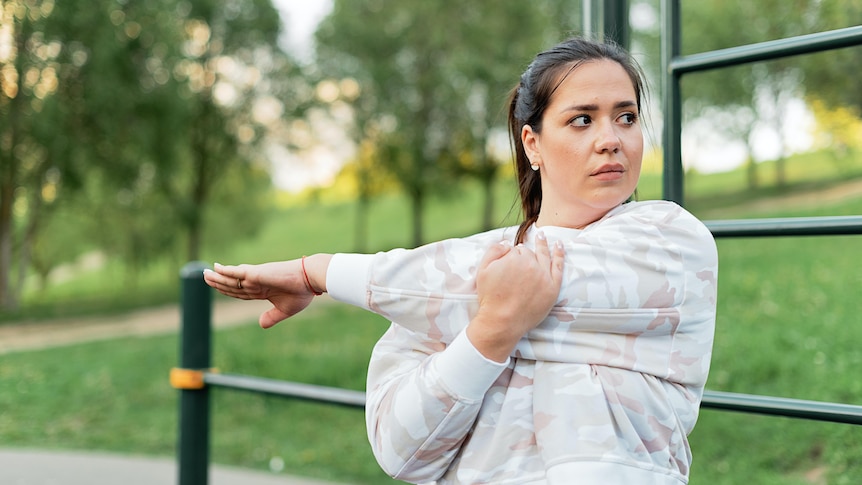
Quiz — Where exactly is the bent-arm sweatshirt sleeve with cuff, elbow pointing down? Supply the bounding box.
[365,325,507,483]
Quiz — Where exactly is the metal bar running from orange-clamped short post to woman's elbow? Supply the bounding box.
[204,372,365,408]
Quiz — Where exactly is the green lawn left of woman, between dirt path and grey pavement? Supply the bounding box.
[0,303,394,484]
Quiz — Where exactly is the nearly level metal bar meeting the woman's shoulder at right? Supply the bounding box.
[704,216,862,237]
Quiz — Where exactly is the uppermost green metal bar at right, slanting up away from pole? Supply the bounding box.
[668,26,862,76]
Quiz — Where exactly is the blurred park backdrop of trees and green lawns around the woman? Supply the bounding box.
[0,0,862,484]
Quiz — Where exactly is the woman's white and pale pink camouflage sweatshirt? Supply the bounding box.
[327,201,717,485]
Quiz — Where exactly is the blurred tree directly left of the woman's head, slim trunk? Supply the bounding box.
[444,1,564,230]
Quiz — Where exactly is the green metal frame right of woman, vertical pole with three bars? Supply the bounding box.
[661,0,862,425]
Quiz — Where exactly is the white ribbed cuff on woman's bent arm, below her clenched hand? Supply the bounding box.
[434,332,510,401]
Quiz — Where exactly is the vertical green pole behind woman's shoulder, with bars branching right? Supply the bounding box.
[661,0,684,205]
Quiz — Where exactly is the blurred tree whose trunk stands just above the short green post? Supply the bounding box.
[110,0,289,260]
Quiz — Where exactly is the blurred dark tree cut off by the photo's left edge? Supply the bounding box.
[0,0,74,308]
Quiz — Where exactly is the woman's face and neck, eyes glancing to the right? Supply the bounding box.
[521,59,643,228]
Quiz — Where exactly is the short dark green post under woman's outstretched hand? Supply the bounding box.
[177,261,212,485]
